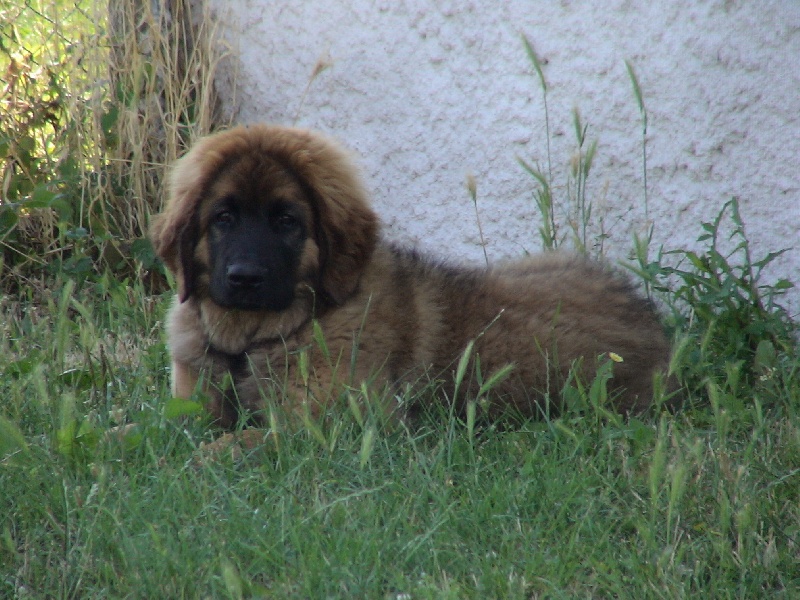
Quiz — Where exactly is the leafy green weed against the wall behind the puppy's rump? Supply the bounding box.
[634,199,797,404]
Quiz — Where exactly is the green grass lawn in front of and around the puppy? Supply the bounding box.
[0,280,800,598]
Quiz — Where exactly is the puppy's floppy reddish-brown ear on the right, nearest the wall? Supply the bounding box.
[270,128,378,304]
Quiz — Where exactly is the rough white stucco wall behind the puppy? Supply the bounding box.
[209,0,800,312]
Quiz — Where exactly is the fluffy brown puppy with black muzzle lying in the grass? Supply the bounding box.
[152,125,669,427]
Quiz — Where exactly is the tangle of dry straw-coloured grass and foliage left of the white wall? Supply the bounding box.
[0,0,227,290]
